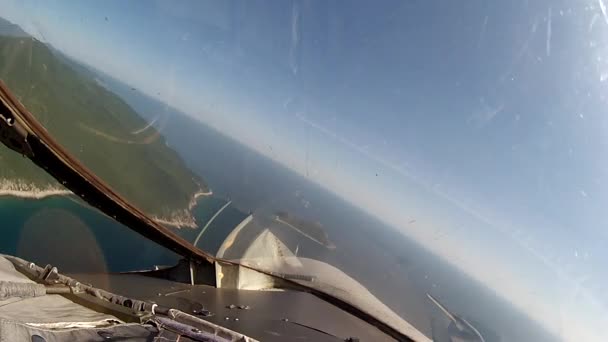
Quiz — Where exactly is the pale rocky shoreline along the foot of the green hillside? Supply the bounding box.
[0,179,213,229]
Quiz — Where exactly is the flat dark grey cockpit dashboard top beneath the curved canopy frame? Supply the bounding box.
[71,274,393,341]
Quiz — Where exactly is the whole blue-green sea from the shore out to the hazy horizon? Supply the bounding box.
[0,74,556,341]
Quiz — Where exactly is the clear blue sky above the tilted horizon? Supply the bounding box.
[0,0,608,339]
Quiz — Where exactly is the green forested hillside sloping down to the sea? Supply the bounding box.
[0,36,206,222]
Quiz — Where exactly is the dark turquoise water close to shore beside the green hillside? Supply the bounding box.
[0,196,230,272]
